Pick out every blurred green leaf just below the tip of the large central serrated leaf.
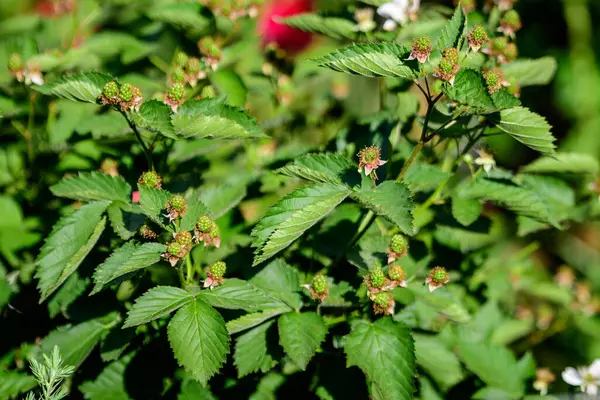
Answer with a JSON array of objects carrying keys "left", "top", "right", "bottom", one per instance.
[{"left": 250, "top": 259, "right": 302, "bottom": 310}]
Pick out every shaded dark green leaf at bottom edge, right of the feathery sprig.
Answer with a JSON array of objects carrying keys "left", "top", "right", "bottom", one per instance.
[{"left": 79, "top": 354, "right": 133, "bottom": 400}]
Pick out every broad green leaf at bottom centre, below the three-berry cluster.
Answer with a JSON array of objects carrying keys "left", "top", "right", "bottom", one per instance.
[{"left": 342, "top": 318, "right": 415, "bottom": 400}]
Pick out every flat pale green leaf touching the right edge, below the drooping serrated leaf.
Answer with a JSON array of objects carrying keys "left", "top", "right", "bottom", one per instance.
[{"left": 523, "top": 153, "right": 600, "bottom": 175}]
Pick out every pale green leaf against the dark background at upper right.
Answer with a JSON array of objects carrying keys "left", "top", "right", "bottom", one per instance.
[{"left": 501, "top": 56, "right": 557, "bottom": 87}]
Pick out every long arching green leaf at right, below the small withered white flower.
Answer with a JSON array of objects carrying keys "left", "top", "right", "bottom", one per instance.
[{"left": 460, "top": 178, "right": 555, "bottom": 224}]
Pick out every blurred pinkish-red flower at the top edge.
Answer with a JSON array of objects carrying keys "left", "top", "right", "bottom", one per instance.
[{"left": 258, "top": 0, "right": 313, "bottom": 53}]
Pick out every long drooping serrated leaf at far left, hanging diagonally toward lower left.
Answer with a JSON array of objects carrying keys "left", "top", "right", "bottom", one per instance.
[{"left": 36, "top": 201, "right": 110, "bottom": 302}]
